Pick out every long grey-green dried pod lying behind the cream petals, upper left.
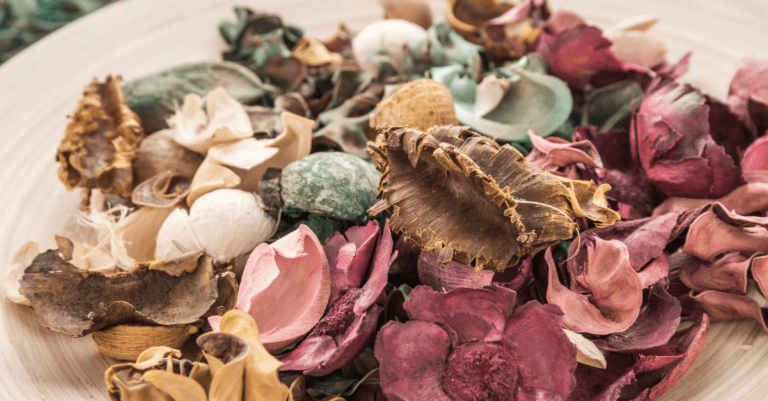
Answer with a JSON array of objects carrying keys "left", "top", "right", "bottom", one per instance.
[{"left": 123, "top": 61, "right": 275, "bottom": 133}]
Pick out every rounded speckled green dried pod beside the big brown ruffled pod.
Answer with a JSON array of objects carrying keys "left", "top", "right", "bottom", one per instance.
[{"left": 280, "top": 152, "right": 380, "bottom": 219}]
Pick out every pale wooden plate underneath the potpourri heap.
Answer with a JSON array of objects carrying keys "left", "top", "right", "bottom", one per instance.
[{"left": 0, "top": 0, "right": 768, "bottom": 401}]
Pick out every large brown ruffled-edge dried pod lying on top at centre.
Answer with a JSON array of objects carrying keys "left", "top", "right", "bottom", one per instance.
[{"left": 368, "top": 126, "right": 609, "bottom": 271}]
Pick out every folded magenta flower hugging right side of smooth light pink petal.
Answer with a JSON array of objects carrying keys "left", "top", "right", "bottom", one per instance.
[{"left": 279, "top": 220, "right": 397, "bottom": 376}]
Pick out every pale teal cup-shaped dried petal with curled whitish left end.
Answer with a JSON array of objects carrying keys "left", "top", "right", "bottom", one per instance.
[{"left": 432, "top": 54, "right": 573, "bottom": 142}]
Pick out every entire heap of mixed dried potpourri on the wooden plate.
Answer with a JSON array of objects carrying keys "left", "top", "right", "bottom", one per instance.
[{"left": 3, "top": 0, "right": 768, "bottom": 401}]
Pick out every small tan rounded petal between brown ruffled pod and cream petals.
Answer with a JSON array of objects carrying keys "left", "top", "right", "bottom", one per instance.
[{"left": 133, "top": 133, "right": 203, "bottom": 185}]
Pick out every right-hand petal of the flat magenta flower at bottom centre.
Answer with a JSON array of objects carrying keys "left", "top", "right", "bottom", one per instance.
[{"left": 503, "top": 301, "right": 576, "bottom": 400}]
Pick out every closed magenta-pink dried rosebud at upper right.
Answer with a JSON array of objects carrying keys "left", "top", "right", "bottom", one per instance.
[{"left": 630, "top": 79, "right": 742, "bottom": 198}]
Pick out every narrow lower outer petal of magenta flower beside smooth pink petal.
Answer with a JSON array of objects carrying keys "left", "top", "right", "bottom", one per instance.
[{"left": 304, "top": 305, "right": 384, "bottom": 376}]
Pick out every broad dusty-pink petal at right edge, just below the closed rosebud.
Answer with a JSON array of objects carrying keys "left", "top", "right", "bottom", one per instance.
[{"left": 683, "top": 208, "right": 768, "bottom": 261}]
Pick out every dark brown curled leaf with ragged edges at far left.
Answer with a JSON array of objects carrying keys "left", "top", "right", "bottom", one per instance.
[{"left": 20, "top": 250, "right": 218, "bottom": 337}]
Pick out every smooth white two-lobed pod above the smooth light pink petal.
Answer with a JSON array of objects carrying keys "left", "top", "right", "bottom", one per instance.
[{"left": 153, "top": 189, "right": 277, "bottom": 264}]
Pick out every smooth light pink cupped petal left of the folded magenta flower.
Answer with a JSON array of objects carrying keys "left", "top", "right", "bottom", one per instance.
[{"left": 209, "top": 224, "right": 331, "bottom": 353}]
